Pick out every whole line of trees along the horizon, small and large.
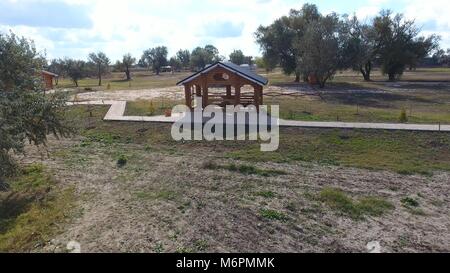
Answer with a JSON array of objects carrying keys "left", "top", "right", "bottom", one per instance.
[{"left": 43, "top": 4, "right": 450, "bottom": 87}]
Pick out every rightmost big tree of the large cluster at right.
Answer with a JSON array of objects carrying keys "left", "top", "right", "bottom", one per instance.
[{"left": 373, "top": 11, "right": 438, "bottom": 81}]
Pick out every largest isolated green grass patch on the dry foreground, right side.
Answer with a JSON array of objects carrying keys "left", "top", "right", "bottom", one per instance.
[{"left": 318, "top": 188, "right": 394, "bottom": 219}]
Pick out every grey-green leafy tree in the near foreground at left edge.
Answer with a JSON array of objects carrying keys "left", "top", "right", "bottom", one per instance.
[{"left": 0, "top": 33, "right": 72, "bottom": 183}]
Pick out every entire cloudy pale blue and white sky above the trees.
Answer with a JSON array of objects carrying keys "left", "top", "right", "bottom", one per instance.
[{"left": 0, "top": 0, "right": 450, "bottom": 60}]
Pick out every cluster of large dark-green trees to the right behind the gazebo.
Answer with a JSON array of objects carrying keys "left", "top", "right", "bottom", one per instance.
[{"left": 255, "top": 4, "right": 443, "bottom": 87}]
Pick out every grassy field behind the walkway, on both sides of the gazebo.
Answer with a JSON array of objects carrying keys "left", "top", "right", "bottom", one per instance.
[{"left": 103, "top": 68, "right": 450, "bottom": 124}]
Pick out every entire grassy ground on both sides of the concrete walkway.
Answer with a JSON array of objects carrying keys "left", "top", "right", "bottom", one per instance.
[{"left": 0, "top": 66, "right": 450, "bottom": 253}]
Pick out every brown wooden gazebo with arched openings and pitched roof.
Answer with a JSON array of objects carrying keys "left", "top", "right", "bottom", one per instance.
[{"left": 177, "top": 62, "right": 268, "bottom": 109}]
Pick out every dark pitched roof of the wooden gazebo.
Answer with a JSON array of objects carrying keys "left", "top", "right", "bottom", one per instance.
[{"left": 177, "top": 62, "right": 269, "bottom": 85}]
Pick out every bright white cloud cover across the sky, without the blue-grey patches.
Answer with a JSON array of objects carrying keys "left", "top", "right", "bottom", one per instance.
[{"left": 0, "top": 0, "right": 450, "bottom": 60}]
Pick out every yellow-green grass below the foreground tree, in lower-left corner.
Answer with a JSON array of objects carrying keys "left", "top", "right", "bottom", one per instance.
[{"left": 0, "top": 165, "right": 74, "bottom": 252}]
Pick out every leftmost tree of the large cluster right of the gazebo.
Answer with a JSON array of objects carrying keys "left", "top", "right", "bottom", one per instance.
[{"left": 255, "top": 4, "right": 321, "bottom": 82}]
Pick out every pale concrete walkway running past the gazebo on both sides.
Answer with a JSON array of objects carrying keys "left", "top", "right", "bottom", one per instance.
[{"left": 67, "top": 101, "right": 450, "bottom": 132}]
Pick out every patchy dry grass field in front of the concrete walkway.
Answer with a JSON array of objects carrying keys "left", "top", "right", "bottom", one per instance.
[{"left": 20, "top": 103, "right": 442, "bottom": 253}]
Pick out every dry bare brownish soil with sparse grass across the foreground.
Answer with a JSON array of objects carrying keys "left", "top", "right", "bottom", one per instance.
[{"left": 21, "top": 138, "right": 450, "bottom": 252}]
